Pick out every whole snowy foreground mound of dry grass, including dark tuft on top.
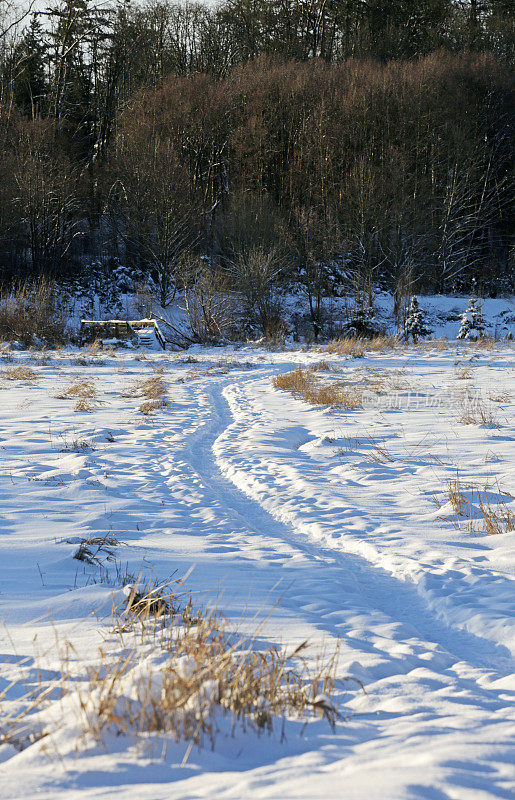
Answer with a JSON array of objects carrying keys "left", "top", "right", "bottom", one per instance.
[{"left": 0, "top": 582, "right": 361, "bottom": 763}]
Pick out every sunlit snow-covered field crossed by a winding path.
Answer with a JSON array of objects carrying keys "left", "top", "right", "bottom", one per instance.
[{"left": 0, "top": 343, "right": 515, "bottom": 800}]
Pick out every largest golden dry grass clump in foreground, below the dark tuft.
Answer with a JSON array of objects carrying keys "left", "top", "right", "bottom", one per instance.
[{"left": 82, "top": 606, "right": 339, "bottom": 760}]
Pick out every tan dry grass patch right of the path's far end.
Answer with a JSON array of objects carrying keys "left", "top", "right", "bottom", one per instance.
[{"left": 273, "top": 367, "right": 363, "bottom": 411}]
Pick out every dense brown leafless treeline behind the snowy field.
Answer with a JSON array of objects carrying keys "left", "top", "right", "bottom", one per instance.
[{"left": 0, "top": 0, "right": 513, "bottom": 306}]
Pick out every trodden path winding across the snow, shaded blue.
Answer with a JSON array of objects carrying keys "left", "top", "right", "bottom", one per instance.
[{"left": 177, "top": 379, "right": 513, "bottom": 675}]
